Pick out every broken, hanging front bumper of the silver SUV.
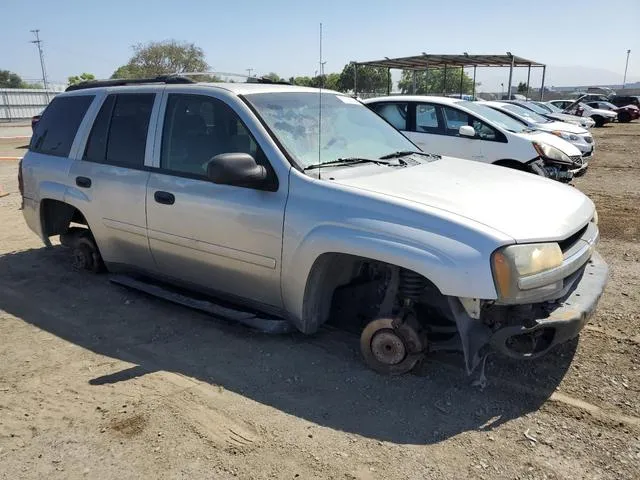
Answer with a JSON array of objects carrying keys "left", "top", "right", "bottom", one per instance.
[{"left": 489, "top": 252, "right": 609, "bottom": 359}]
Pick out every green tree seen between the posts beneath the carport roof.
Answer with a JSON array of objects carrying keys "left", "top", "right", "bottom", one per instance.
[{"left": 398, "top": 67, "right": 473, "bottom": 94}]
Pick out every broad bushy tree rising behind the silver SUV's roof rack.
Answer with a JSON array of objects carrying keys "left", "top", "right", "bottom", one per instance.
[{"left": 111, "top": 40, "right": 209, "bottom": 80}]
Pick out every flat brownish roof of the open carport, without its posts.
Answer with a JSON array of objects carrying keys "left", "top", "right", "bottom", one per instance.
[{"left": 356, "top": 53, "right": 545, "bottom": 70}]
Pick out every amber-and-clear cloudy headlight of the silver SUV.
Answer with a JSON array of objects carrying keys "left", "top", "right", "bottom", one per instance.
[{"left": 491, "top": 243, "right": 564, "bottom": 301}]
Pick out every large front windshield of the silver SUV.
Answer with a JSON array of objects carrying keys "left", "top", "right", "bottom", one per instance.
[{"left": 246, "top": 92, "right": 418, "bottom": 168}]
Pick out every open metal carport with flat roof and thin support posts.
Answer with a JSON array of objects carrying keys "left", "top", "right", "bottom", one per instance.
[{"left": 353, "top": 52, "right": 547, "bottom": 98}]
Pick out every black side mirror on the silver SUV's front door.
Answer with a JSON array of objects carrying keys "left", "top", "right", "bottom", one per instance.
[{"left": 207, "top": 153, "right": 267, "bottom": 187}]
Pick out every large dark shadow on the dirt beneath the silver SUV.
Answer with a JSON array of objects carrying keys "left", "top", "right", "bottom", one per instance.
[{"left": 0, "top": 247, "right": 576, "bottom": 444}]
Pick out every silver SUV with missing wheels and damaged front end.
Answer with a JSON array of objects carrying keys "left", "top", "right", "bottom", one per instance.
[{"left": 20, "top": 76, "right": 607, "bottom": 374}]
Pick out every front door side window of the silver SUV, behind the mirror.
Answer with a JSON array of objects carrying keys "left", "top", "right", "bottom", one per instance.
[{"left": 160, "top": 94, "right": 266, "bottom": 176}]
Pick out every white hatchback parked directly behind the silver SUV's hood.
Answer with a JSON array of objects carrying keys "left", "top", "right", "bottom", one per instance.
[{"left": 364, "top": 95, "right": 583, "bottom": 182}]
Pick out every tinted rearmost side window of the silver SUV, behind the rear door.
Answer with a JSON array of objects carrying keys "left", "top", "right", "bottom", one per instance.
[{"left": 29, "top": 95, "right": 94, "bottom": 157}]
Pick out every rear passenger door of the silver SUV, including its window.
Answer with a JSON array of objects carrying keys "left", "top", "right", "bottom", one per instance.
[{"left": 68, "top": 89, "right": 159, "bottom": 271}]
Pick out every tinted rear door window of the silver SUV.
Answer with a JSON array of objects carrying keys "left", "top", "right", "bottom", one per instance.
[{"left": 84, "top": 93, "right": 155, "bottom": 168}]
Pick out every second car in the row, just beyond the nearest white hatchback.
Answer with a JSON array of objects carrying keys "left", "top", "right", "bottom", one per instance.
[{"left": 484, "top": 101, "right": 595, "bottom": 161}]
